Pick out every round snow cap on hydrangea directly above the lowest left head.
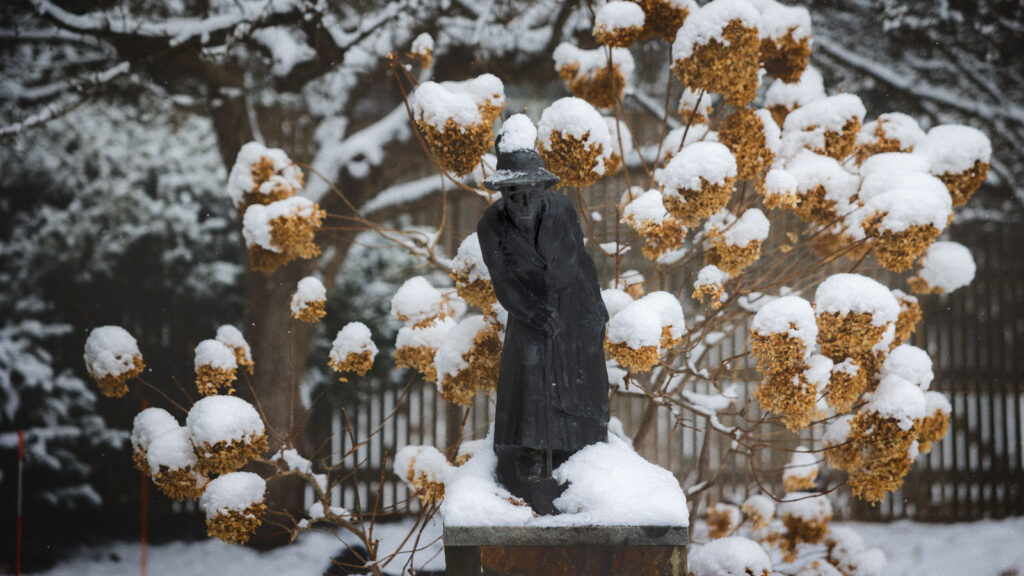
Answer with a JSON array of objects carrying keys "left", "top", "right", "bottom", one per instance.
[{"left": 185, "top": 396, "right": 263, "bottom": 446}]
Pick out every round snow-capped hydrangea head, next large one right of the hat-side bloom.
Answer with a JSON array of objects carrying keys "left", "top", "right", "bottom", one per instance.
[{"left": 654, "top": 141, "right": 737, "bottom": 225}]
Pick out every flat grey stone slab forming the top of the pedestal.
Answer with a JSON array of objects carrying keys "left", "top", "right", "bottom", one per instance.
[{"left": 443, "top": 526, "right": 689, "bottom": 546}]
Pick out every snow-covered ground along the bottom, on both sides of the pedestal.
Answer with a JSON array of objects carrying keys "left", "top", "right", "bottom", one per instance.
[{"left": 25, "top": 518, "right": 1024, "bottom": 576}]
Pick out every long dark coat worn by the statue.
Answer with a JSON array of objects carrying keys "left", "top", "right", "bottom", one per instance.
[{"left": 477, "top": 192, "right": 608, "bottom": 452}]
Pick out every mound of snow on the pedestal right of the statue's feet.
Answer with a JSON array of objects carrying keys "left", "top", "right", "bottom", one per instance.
[{"left": 553, "top": 435, "right": 689, "bottom": 526}]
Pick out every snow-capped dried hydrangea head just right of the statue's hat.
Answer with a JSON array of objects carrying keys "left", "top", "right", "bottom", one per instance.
[{"left": 537, "top": 97, "right": 614, "bottom": 188}]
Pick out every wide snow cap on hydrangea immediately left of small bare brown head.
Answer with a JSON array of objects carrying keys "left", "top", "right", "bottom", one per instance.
[{"left": 814, "top": 274, "right": 899, "bottom": 326}]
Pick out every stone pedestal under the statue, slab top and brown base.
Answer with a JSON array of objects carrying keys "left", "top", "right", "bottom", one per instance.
[{"left": 444, "top": 526, "right": 688, "bottom": 576}]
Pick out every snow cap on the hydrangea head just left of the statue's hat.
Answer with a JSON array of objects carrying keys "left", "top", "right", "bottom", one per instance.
[{"left": 412, "top": 74, "right": 505, "bottom": 130}]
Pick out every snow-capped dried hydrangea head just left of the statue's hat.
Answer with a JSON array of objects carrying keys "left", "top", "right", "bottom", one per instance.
[{"left": 412, "top": 74, "right": 505, "bottom": 176}]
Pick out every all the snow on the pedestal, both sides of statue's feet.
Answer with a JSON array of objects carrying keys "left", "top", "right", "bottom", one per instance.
[{"left": 440, "top": 434, "right": 689, "bottom": 527}]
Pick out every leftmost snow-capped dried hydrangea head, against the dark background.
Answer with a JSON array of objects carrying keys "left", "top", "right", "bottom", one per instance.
[{"left": 84, "top": 326, "right": 145, "bottom": 398}]
